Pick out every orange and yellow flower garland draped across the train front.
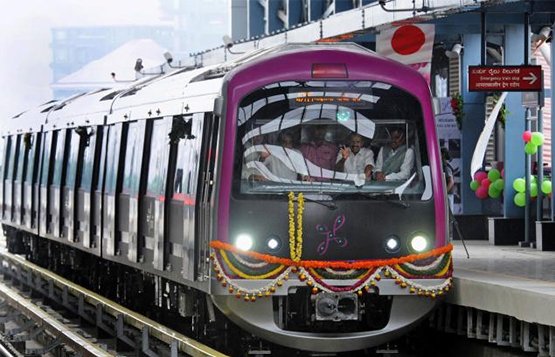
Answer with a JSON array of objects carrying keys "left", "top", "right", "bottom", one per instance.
[{"left": 210, "top": 192, "right": 453, "bottom": 301}]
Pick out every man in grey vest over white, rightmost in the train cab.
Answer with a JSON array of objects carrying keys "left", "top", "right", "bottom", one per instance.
[{"left": 374, "top": 127, "right": 414, "bottom": 181}]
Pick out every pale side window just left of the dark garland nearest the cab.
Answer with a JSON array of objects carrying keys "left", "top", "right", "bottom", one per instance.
[{"left": 146, "top": 117, "right": 173, "bottom": 196}]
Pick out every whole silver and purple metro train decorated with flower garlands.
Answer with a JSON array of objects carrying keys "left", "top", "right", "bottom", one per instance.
[{"left": 0, "top": 43, "right": 453, "bottom": 353}]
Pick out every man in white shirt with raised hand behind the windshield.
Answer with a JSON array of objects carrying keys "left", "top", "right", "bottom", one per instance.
[{"left": 335, "top": 133, "right": 376, "bottom": 179}]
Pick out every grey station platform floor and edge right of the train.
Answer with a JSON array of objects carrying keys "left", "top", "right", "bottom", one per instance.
[{"left": 446, "top": 237, "right": 555, "bottom": 327}]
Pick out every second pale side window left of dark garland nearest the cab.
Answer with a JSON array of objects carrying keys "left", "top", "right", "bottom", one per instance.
[{"left": 122, "top": 121, "right": 145, "bottom": 195}]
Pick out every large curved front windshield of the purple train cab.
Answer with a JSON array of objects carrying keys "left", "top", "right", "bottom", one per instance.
[{"left": 234, "top": 81, "right": 431, "bottom": 199}]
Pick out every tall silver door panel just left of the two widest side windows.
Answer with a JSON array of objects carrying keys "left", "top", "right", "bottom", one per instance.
[{"left": 101, "top": 123, "right": 125, "bottom": 257}]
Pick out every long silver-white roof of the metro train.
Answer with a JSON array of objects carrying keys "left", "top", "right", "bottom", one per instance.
[{"left": 4, "top": 43, "right": 396, "bottom": 135}]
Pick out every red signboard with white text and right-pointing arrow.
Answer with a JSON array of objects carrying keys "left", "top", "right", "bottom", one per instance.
[{"left": 468, "top": 65, "right": 543, "bottom": 92}]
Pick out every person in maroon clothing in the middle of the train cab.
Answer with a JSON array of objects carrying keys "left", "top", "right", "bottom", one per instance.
[{"left": 301, "top": 125, "right": 337, "bottom": 170}]
